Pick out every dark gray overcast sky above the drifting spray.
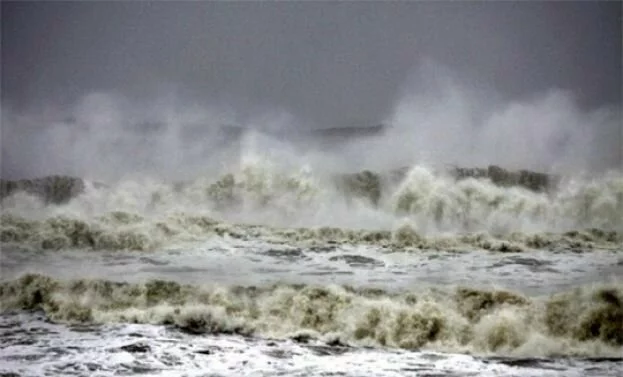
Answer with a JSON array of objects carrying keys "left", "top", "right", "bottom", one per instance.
[{"left": 2, "top": 1, "right": 622, "bottom": 126}]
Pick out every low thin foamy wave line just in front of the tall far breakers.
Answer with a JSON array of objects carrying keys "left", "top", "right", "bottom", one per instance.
[{"left": 0, "top": 212, "right": 623, "bottom": 252}]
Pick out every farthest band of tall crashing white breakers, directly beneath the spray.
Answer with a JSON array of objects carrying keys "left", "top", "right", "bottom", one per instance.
[{"left": 0, "top": 161, "right": 623, "bottom": 251}]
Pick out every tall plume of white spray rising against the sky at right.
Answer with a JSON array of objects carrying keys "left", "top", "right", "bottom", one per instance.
[{"left": 388, "top": 62, "right": 621, "bottom": 174}]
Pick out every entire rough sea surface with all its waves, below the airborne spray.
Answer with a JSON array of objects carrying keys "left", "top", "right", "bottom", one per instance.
[{"left": 0, "top": 160, "right": 623, "bottom": 377}]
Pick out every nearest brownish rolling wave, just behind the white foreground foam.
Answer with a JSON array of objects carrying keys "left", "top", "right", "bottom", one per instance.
[{"left": 0, "top": 274, "right": 623, "bottom": 357}]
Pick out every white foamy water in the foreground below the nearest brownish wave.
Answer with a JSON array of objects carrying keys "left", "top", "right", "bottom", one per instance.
[{"left": 0, "top": 314, "right": 623, "bottom": 377}]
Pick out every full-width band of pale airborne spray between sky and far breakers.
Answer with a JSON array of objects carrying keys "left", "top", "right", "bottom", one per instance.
[{"left": 2, "top": 61, "right": 622, "bottom": 181}]
